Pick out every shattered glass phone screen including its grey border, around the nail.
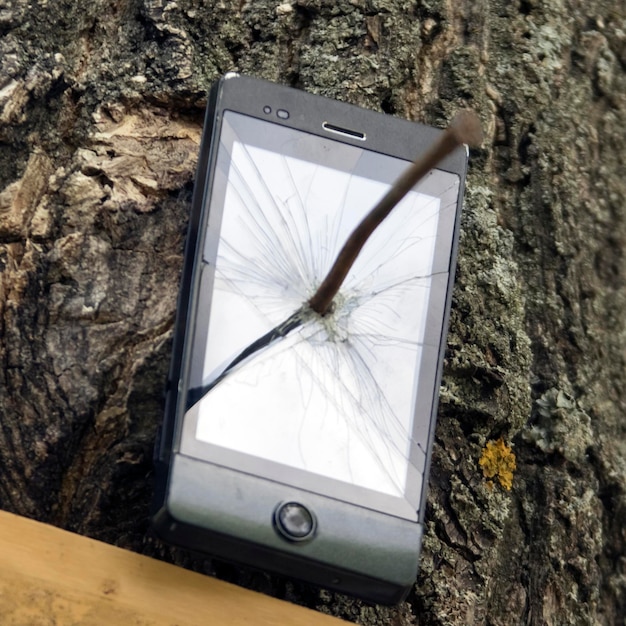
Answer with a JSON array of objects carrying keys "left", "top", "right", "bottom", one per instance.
[{"left": 181, "top": 112, "right": 459, "bottom": 519}]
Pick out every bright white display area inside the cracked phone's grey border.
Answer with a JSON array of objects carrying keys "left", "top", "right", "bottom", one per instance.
[{"left": 189, "top": 136, "right": 444, "bottom": 496}]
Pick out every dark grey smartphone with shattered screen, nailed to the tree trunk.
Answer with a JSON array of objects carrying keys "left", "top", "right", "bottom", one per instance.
[{"left": 153, "top": 73, "right": 467, "bottom": 604}]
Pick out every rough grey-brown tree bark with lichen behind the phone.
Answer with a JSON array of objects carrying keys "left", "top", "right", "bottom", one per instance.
[{"left": 0, "top": 0, "right": 626, "bottom": 626}]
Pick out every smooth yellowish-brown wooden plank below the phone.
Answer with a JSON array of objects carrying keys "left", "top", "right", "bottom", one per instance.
[{"left": 0, "top": 511, "right": 346, "bottom": 626}]
